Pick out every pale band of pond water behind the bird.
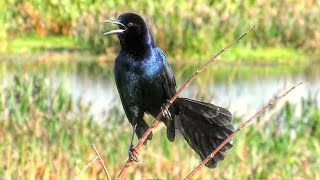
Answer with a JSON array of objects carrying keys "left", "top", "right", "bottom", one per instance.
[{"left": 0, "top": 59, "right": 320, "bottom": 119}]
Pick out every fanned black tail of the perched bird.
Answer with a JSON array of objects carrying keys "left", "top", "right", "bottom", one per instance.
[{"left": 174, "top": 98, "right": 234, "bottom": 168}]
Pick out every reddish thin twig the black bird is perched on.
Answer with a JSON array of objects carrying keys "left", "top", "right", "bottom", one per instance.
[{"left": 117, "top": 26, "right": 255, "bottom": 179}]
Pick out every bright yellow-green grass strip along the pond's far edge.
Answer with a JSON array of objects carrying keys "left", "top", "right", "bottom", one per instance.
[{"left": 0, "top": 35, "right": 310, "bottom": 65}]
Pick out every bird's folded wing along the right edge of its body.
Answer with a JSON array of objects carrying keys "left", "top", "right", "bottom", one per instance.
[{"left": 157, "top": 48, "right": 176, "bottom": 99}]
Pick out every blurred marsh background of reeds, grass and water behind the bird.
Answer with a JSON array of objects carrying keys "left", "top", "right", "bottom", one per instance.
[{"left": 0, "top": 0, "right": 320, "bottom": 179}]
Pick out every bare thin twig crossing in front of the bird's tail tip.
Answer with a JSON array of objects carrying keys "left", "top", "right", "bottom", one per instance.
[{"left": 185, "top": 82, "right": 302, "bottom": 180}]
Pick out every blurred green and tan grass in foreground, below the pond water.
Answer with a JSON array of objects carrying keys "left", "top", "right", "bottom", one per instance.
[{"left": 0, "top": 75, "right": 320, "bottom": 179}]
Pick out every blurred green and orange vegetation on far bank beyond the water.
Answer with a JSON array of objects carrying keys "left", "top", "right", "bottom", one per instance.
[{"left": 0, "top": 0, "right": 320, "bottom": 60}]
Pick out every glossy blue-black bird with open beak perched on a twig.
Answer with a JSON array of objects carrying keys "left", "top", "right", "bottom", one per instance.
[{"left": 104, "top": 13, "right": 234, "bottom": 168}]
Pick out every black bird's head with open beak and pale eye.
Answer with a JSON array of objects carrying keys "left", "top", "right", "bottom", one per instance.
[{"left": 103, "top": 13, "right": 154, "bottom": 49}]
